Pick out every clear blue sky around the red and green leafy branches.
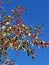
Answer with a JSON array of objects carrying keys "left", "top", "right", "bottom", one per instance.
[{"left": 2, "top": 0, "right": 49, "bottom": 65}]
